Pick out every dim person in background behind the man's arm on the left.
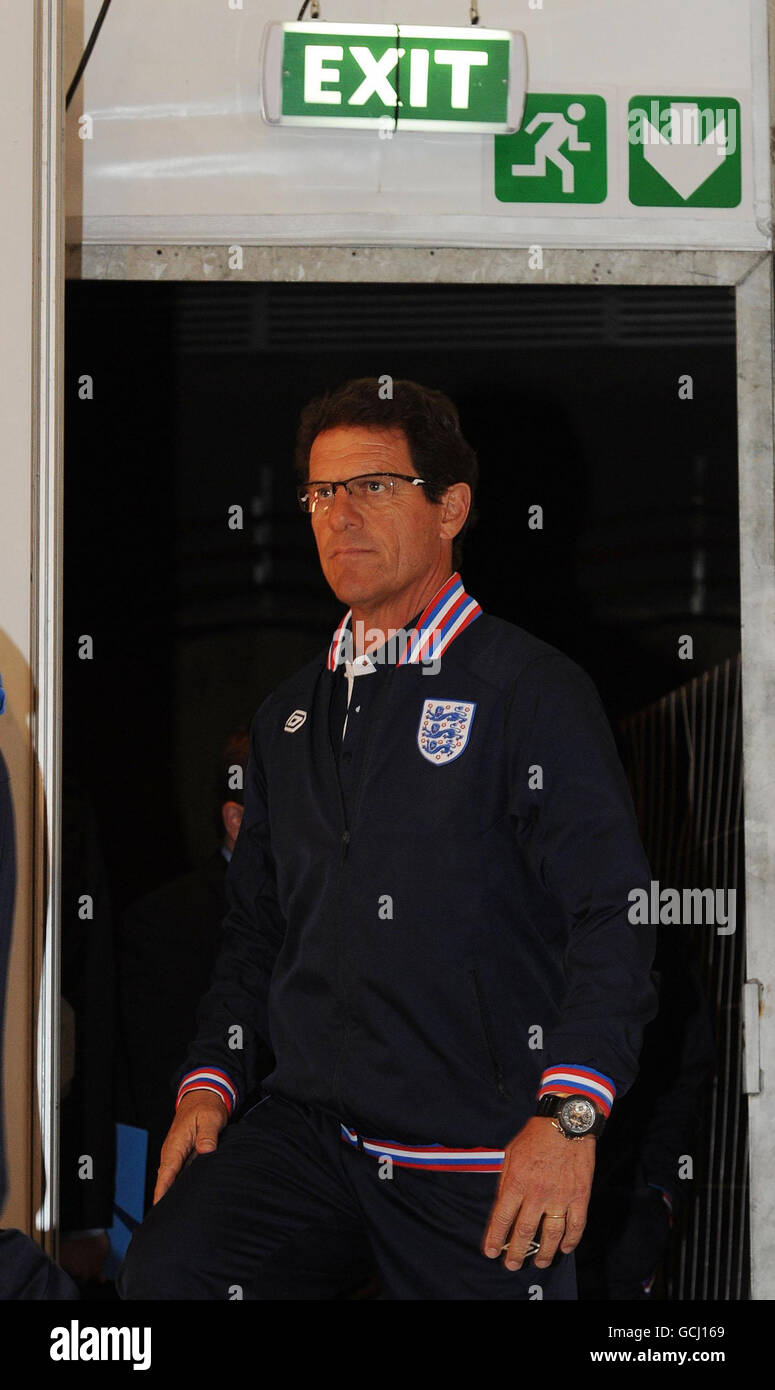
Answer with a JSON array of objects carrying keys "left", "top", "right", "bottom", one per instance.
[{"left": 119, "top": 727, "right": 272, "bottom": 1208}]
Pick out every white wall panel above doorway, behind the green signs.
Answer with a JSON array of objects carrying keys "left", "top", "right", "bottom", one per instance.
[{"left": 67, "top": 0, "right": 769, "bottom": 249}]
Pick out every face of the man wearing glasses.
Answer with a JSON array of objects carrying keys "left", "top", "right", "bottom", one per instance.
[{"left": 310, "top": 425, "right": 449, "bottom": 607}]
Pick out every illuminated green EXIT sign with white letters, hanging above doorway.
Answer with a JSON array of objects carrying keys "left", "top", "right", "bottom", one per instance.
[{"left": 261, "top": 21, "right": 526, "bottom": 135}]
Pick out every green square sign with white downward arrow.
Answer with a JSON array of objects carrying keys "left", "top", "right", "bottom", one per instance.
[{"left": 628, "top": 96, "right": 740, "bottom": 207}]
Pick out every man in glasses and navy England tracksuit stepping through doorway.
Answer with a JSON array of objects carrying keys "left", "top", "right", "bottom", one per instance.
[{"left": 119, "top": 379, "right": 656, "bottom": 1300}]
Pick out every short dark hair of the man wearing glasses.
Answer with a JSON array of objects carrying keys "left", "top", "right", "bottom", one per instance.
[{"left": 293, "top": 377, "right": 479, "bottom": 570}]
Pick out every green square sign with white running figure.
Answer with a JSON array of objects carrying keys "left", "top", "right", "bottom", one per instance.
[{"left": 494, "top": 92, "right": 607, "bottom": 203}]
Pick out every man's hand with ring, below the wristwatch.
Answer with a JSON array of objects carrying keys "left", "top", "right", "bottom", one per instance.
[{"left": 482, "top": 1115, "right": 597, "bottom": 1269}]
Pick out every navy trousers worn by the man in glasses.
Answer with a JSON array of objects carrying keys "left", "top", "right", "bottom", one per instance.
[{"left": 117, "top": 1095, "right": 576, "bottom": 1300}]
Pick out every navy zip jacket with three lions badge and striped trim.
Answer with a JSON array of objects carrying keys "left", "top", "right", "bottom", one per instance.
[{"left": 174, "top": 573, "right": 656, "bottom": 1148}]
